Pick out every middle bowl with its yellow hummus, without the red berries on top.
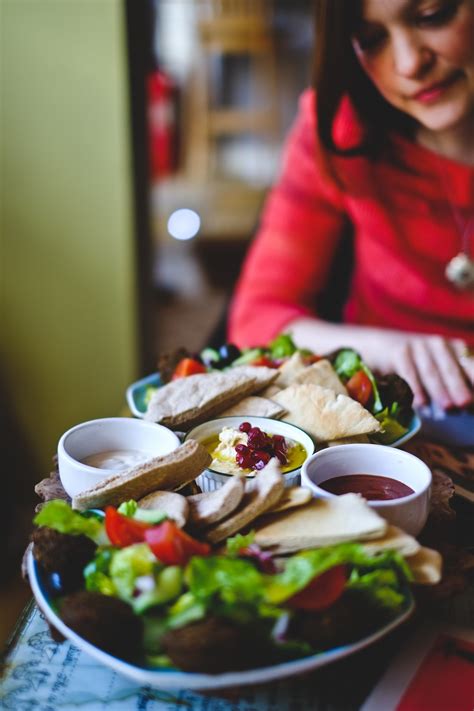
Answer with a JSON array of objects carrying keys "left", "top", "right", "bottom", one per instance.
[{"left": 185, "top": 415, "right": 314, "bottom": 491}]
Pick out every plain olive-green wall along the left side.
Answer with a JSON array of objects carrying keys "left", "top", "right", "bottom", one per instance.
[{"left": 0, "top": 0, "right": 139, "bottom": 471}]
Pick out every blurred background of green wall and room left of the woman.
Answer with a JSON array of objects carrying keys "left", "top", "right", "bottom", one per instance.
[{"left": 0, "top": 0, "right": 312, "bottom": 641}]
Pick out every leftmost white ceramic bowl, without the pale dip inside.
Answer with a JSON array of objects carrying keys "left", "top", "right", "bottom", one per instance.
[{"left": 58, "top": 417, "right": 180, "bottom": 498}]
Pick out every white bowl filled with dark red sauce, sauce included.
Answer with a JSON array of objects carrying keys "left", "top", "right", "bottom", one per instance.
[{"left": 301, "top": 444, "right": 432, "bottom": 536}]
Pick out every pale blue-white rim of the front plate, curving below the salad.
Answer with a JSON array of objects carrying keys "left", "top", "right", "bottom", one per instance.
[{"left": 27, "top": 551, "right": 414, "bottom": 689}]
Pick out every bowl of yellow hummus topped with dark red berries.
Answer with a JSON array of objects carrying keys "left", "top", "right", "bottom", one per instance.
[{"left": 185, "top": 416, "right": 314, "bottom": 491}]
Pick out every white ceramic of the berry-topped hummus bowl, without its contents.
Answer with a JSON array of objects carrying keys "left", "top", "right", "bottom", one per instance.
[{"left": 185, "top": 415, "right": 314, "bottom": 491}]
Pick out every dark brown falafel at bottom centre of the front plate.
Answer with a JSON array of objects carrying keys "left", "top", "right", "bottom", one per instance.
[{"left": 163, "top": 617, "right": 274, "bottom": 674}]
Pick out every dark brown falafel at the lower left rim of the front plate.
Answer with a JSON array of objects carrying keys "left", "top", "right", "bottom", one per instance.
[{"left": 59, "top": 590, "right": 143, "bottom": 661}]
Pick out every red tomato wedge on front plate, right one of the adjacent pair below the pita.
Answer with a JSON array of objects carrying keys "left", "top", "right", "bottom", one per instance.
[{"left": 145, "top": 521, "right": 211, "bottom": 565}]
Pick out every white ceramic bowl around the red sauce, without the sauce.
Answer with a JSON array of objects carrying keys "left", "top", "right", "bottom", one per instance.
[{"left": 301, "top": 444, "right": 431, "bottom": 536}]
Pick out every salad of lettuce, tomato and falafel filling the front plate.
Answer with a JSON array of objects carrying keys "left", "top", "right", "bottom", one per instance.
[{"left": 32, "top": 500, "right": 412, "bottom": 673}]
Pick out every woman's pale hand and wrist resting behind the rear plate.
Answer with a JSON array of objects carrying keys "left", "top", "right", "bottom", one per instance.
[{"left": 287, "top": 318, "right": 474, "bottom": 410}]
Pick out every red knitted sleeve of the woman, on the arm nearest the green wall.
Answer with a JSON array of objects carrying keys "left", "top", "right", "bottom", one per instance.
[{"left": 228, "top": 90, "right": 347, "bottom": 347}]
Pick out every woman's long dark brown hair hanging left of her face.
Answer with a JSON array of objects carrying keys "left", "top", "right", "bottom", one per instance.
[{"left": 313, "top": 0, "right": 413, "bottom": 157}]
